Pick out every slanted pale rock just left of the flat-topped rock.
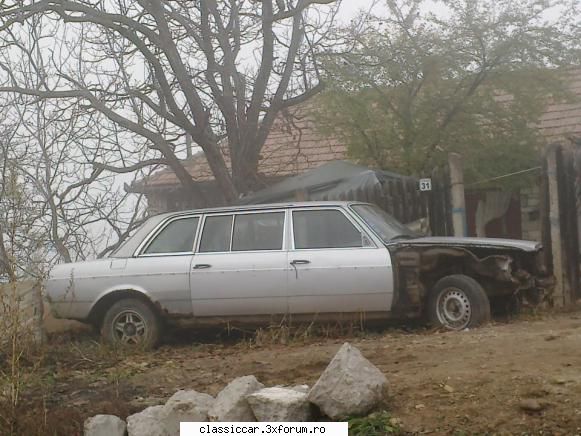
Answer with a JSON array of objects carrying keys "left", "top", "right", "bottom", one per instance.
[{"left": 208, "top": 375, "right": 264, "bottom": 422}]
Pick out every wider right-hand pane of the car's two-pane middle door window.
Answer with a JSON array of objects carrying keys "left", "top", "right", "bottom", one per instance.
[{"left": 232, "top": 212, "right": 284, "bottom": 251}]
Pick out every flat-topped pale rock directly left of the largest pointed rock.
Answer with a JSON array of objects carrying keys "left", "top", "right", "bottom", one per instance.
[{"left": 246, "top": 387, "right": 311, "bottom": 422}]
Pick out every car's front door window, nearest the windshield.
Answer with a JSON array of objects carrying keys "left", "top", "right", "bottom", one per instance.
[{"left": 293, "top": 209, "right": 370, "bottom": 249}]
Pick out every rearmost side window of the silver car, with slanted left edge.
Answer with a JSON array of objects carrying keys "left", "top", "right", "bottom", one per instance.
[{"left": 143, "top": 217, "right": 199, "bottom": 254}]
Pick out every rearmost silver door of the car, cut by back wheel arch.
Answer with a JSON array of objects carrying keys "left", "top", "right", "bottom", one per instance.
[{"left": 119, "top": 216, "right": 200, "bottom": 315}]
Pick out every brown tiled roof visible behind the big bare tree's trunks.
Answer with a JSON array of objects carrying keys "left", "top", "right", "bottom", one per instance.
[{"left": 132, "top": 107, "right": 347, "bottom": 190}]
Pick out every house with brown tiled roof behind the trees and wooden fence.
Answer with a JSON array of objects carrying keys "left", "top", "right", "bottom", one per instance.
[{"left": 130, "top": 70, "right": 581, "bottom": 240}]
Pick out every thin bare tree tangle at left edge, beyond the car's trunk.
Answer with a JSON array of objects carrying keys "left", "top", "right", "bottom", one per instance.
[{"left": 0, "top": 94, "right": 144, "bottom": 281}]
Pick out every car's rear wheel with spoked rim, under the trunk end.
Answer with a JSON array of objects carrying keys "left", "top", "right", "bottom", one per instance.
[{"left": 101, "top": 298, "right": 161, "bottom": 349}]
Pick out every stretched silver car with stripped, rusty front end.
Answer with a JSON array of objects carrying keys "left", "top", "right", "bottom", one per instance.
[{"left": 46, "top": 202, "right": 552, "bottom": 347}]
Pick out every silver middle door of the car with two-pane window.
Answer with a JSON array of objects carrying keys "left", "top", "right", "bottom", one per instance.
[{"left": 190, "top": 210, "right": 288, "bottom": 317}]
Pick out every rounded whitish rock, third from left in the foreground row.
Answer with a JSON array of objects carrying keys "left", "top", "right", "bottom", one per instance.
[{"left": 162, "top": 391, "right": 214, "bottom": 435}]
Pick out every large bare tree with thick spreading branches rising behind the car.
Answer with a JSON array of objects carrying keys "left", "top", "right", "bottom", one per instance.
[{"left": 0, "top": 0, "right": 337, "bottom": 200}]
